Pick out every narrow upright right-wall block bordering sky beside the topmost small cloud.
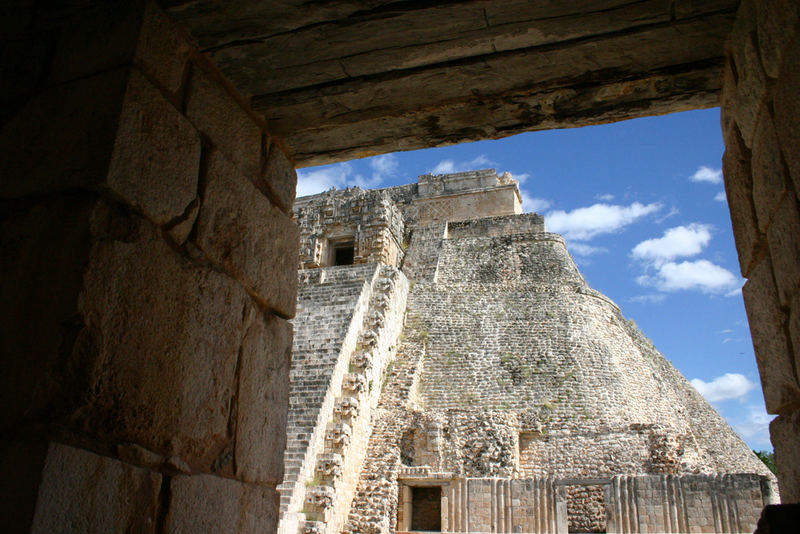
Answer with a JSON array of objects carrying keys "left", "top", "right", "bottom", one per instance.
[{"left": 722, "top": 125, "right": 759, "bottom": 277}]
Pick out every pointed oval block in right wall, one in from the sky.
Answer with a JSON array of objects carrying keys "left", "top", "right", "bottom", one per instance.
[{"left": 752, "top": 109, "right": 789, "bottom": 232}]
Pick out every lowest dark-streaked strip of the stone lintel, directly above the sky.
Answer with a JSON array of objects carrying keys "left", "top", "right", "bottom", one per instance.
[{"left": 276, "top": 59, "right": 722, "bottom": 167}]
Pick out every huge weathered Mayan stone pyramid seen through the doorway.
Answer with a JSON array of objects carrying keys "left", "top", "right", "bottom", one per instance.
[{"left": 279, "top": 170, "right": 778, "bottom": 534}]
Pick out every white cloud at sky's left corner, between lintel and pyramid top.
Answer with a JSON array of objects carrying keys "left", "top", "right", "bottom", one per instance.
[{"left": 297, "top": 154, "right": 400, "bottom": 197}]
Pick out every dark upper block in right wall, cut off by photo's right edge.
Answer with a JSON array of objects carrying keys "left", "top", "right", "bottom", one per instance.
[{"left": 773, "top": 32, "right": 800, "bottom": 196}]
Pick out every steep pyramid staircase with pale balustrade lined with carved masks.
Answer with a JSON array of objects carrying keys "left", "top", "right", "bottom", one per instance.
[{"left": 279, "top": 264, "right": 408, "bottom": 534}]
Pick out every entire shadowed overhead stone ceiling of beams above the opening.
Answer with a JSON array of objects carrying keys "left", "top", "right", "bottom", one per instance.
[{"left": 170, "top": 0, "right": 738, "bottom": 166}]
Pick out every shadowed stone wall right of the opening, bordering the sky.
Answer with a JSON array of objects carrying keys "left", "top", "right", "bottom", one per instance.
[{"left": 722, "top": 0, "right": 800, "bottom": 503}]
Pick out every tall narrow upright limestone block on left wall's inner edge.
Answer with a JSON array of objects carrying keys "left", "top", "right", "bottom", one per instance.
[{"left": 236, "top": 313, "right": 292, "bottom": 485}]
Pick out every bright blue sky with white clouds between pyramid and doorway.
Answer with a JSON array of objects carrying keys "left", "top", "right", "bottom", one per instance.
[{"left": 298, "top": 109, "right": 772, "bottom": 450}]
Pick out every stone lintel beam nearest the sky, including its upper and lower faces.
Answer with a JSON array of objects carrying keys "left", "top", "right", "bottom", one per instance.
[{"left": 251, "top": 13, "right": 732, "bottom": 166}]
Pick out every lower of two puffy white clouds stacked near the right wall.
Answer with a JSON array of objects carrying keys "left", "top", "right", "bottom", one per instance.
[{"left": 636, "top": 260, "right": 739, "bottom": 293}]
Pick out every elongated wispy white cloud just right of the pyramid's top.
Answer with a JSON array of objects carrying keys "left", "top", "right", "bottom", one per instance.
[{"left": 545, "top": 202, "right": 661, "bottom": 241}]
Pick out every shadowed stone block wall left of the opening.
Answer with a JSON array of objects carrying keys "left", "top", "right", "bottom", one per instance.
[{"left": 0, "top": 2, "right": 298, "bottom": 532}]
